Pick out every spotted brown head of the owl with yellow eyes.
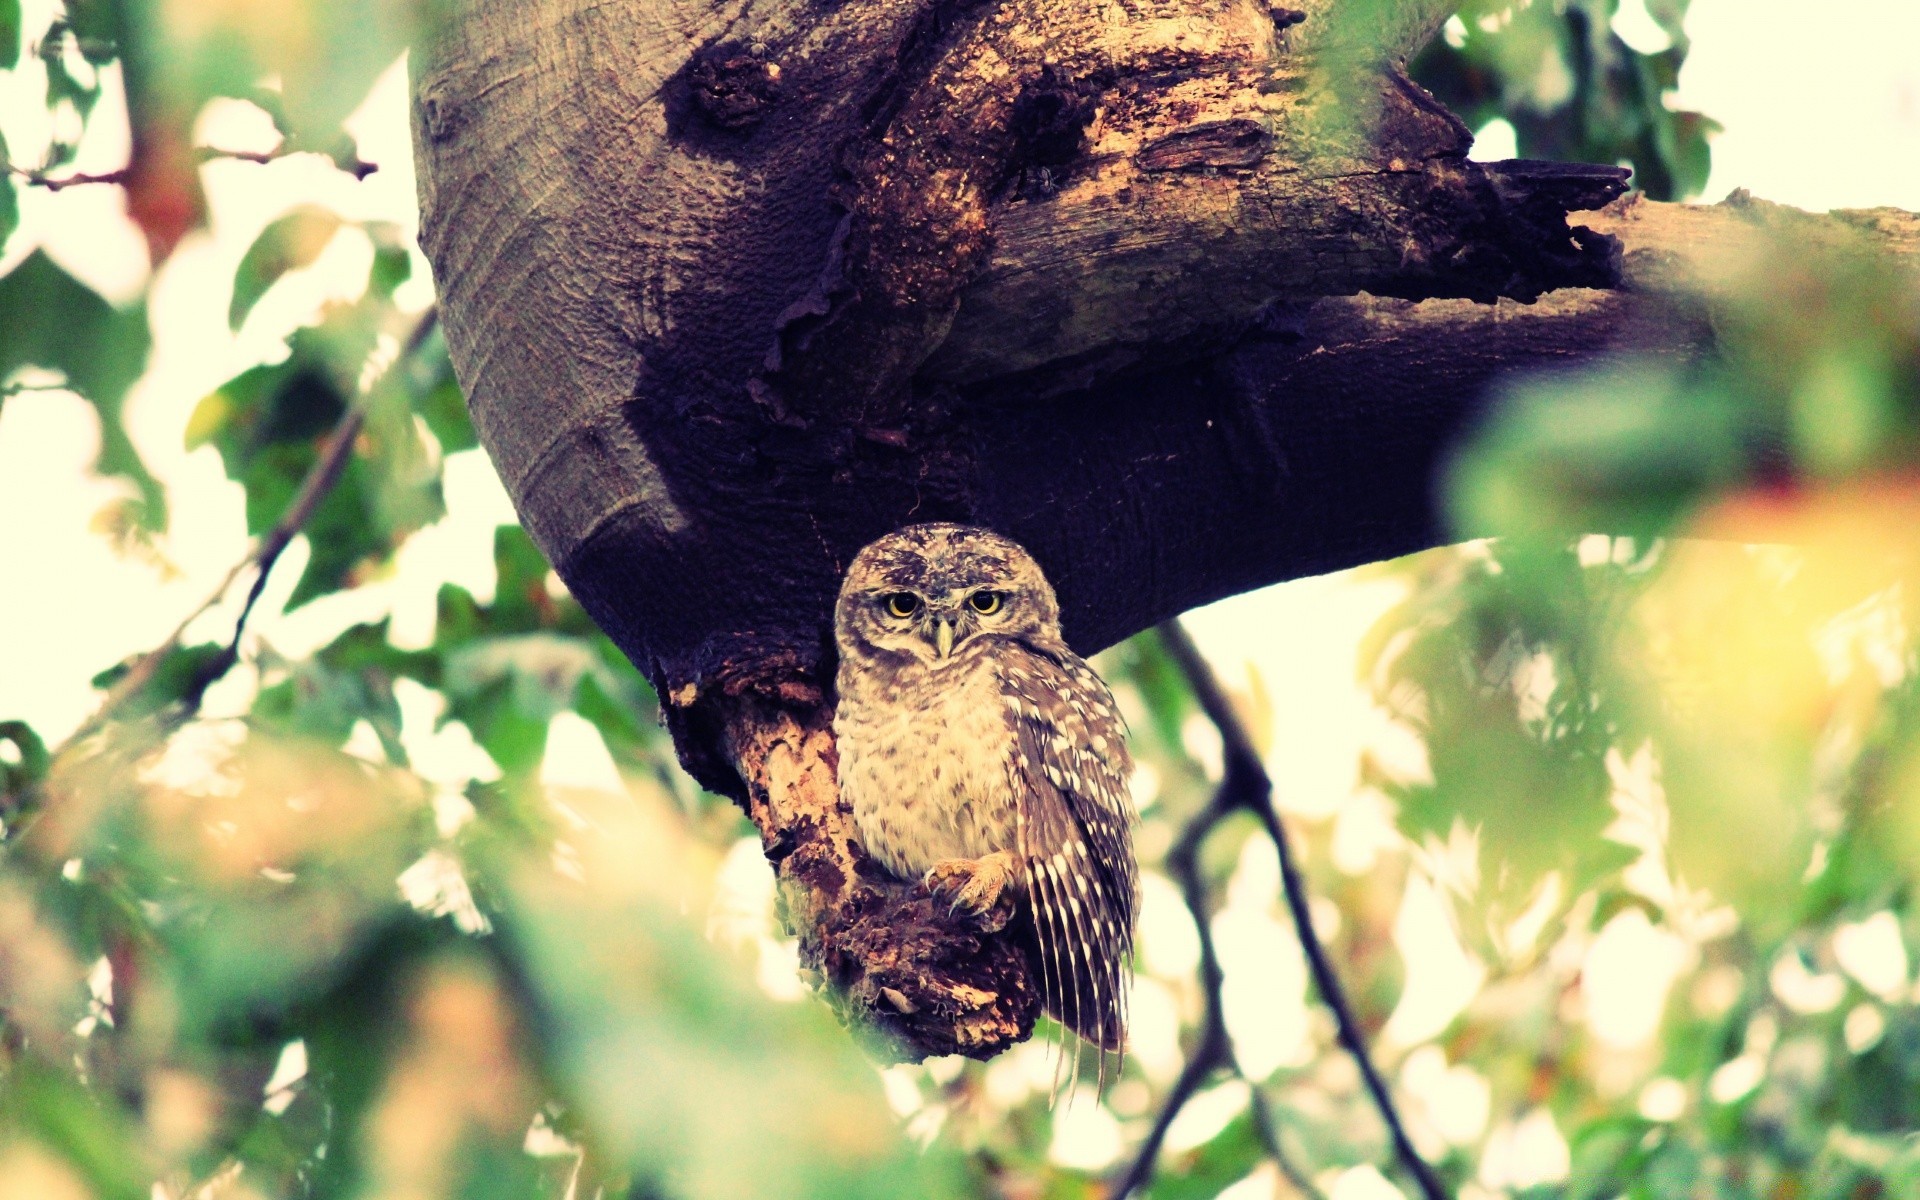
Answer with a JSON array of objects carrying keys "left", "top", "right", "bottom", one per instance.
[{"left": 833, "top": 524, "right": 1060, "bottom": 662}]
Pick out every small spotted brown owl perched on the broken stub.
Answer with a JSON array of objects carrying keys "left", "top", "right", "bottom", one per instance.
[{"left": 833, "top": 524, "right": 1139, "bottom": 1073}]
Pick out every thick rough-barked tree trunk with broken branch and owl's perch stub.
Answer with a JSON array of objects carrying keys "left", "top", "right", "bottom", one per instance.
[{"left": 413, "top": 0, "right": 1920, "bottom": 1056}]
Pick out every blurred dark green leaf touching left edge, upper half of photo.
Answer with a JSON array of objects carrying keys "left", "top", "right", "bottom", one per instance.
[{"left": 0, "top": 250, "right": 167, "bottom": 530}]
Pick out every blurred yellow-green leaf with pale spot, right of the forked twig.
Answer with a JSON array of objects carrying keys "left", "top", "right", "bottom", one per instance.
[{"left": 1363, "top": 540, "right": 1645, "bottom": 937}]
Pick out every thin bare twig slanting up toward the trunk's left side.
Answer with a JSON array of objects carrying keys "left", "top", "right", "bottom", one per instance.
[{"left": 60, "top": 309, "right": 440, "bottom": 753}]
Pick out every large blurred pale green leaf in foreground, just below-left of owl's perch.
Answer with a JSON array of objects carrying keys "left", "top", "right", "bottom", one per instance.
[{"left": 497, "top": 793, "right": 960, "bottom": 1200}]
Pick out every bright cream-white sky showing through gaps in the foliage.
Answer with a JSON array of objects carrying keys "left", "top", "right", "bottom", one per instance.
[{"left": 0, "top": 0, "right": 1920, "bottom": 1196}]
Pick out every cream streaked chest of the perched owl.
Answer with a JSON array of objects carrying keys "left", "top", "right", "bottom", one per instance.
[{"left": 833, "top": 662, "right": 1014, "bottom": 877}]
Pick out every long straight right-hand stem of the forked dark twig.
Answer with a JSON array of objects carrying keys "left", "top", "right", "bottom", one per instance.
[{"left": 1160, "top": 620, "right": 1448, "bottom": 1200}]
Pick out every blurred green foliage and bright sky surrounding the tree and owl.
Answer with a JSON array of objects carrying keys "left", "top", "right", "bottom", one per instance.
[{"left": 0, "top": 0, "right": 1920, "bottom": 1200}]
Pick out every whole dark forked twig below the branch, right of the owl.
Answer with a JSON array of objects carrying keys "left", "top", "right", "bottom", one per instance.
[{"left": 1114, "top": 620, "right": 1448, "bottom": 1200}]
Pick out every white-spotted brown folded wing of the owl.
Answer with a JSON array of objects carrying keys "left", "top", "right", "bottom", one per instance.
[{"left": 1000, "top": 647, "right": 1139, "bottom": 1050}]
